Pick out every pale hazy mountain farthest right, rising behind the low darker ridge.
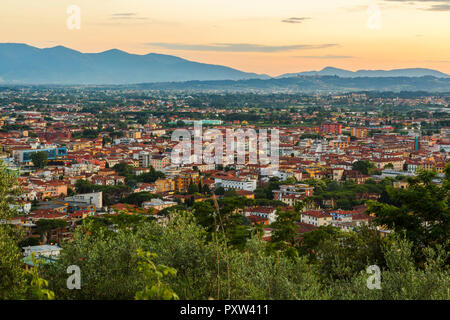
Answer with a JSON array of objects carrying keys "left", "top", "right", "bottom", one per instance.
[{"left": 277, "top": 67, "right": 450, "bottom": 78}]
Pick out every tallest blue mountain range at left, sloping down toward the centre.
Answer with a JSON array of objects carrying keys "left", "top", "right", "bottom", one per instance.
[{"left": 0, "top": 43, "right": 270, "bottom": 84}]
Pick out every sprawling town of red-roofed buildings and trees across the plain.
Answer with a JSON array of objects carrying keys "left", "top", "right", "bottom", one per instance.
[{"left": 0, "top": 87, "right": 450, "bottom": 300}]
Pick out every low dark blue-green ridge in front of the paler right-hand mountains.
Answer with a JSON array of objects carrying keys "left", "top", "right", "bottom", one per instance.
[{"left": 130, "top": 76, "right": 450, "bottom": 93}]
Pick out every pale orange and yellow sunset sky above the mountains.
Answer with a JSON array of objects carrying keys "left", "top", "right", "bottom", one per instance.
[{"left": 0, "top": 0, "right": 450, "bottom": 75}]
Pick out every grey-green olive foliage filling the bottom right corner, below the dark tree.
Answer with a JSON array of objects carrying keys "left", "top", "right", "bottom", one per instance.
[{"left": 329, "top": 234, "right": 450, "bottom": 300}]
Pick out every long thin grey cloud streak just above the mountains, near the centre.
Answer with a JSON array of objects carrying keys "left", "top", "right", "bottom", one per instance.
[{"left": 147, "top": 42, "right": 338, "bottom": 52}]
